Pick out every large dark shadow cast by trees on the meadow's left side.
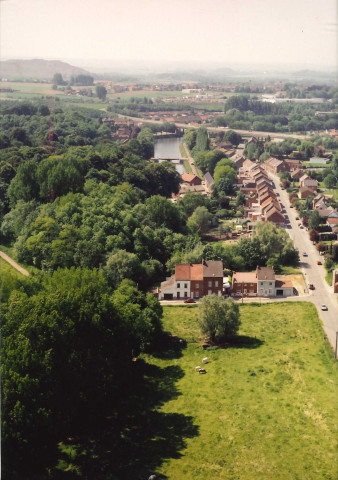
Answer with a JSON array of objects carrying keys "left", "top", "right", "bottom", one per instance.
[{"left": 55, "top": 350, "right": 199, "bottom": 480}]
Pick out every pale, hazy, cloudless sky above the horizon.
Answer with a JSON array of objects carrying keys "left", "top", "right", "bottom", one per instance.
[{"left": 0, "top": 0, "right": 338, "bottom": 69}]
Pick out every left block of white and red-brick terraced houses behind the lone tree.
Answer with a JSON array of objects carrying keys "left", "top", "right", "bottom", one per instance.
[{"left": 160, "top": 260, "right": 223, "bottom": 300}]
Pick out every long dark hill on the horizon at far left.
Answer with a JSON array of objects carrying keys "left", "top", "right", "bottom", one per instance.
[{"left": 0, "top": 59, "right": 89, "bottom": 80}]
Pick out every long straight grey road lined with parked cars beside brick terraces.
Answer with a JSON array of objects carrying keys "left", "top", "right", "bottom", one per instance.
[{"left": 270, "top": 175, "right": 338, "bottom": 348}]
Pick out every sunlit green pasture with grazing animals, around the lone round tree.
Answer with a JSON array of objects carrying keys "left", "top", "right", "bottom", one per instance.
[{"left": 146, "top": 302, "right": 338, "bottom": 480}]
